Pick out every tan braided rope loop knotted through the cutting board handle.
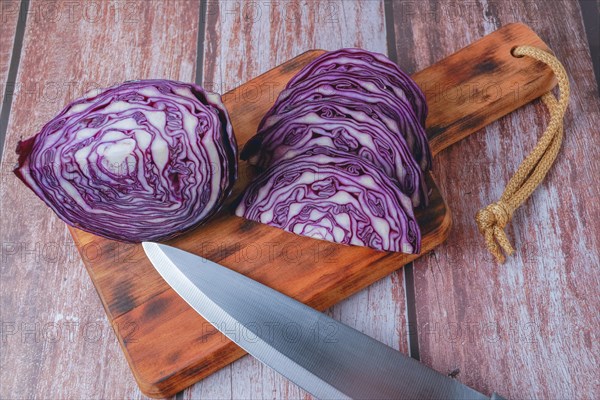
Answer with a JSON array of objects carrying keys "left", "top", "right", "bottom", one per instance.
[{"left": 475, "top": 46, "right": 570, "bottom": 263}]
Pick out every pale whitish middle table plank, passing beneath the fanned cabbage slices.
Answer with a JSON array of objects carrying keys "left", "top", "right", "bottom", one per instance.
[{"left": 192, "top": 1, "right": 407, "bottom": 399}]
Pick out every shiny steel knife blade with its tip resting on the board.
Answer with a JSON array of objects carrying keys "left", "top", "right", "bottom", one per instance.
[{"left": 143, "top": 242, "right": 501, "bottom": 400}]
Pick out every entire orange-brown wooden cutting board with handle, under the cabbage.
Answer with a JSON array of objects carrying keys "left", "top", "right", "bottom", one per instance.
[{"left": 70, "top": 24, "right": 555, "bottom": 397}]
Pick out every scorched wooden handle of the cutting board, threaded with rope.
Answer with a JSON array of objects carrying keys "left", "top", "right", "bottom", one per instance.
[{"left": 412, "top": 23, "right": 556, "bottom": 156}]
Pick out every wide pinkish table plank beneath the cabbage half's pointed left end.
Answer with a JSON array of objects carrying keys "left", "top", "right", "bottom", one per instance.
[{"left": 0, "top": 0, "right": 200, "bottom": 398}]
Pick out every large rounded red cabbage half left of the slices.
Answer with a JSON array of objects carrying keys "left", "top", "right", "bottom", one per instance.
[{"left": 15, "top": 80, "right": 237, "bottom": 242}]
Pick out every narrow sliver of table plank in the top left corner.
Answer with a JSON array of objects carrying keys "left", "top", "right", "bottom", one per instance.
[{"left": 0, "top": 1, "right": 19, "bottom": 110}]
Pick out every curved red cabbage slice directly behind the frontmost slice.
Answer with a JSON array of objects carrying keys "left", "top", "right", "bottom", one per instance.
[{"left": 244, "top": 99, "right": 427, "bottom": 206}]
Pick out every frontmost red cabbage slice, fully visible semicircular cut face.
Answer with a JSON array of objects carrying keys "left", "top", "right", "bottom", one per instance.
[{"left": 236, "top": 149, "right": 421, "bottom": 253}]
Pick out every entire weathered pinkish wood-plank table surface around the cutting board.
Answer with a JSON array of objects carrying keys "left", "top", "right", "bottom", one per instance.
[{"left": 0, "top": 0, "right": 600, "bottom": 399}]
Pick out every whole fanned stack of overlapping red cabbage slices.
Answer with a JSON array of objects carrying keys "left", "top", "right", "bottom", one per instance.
[{"left": 236, "top": 49, "right": 431, "bottom": 253}]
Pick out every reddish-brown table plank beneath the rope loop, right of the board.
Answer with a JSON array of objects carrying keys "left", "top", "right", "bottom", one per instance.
[{"left": 394, "top": 1, "right": 600, "bottom": 398}]
